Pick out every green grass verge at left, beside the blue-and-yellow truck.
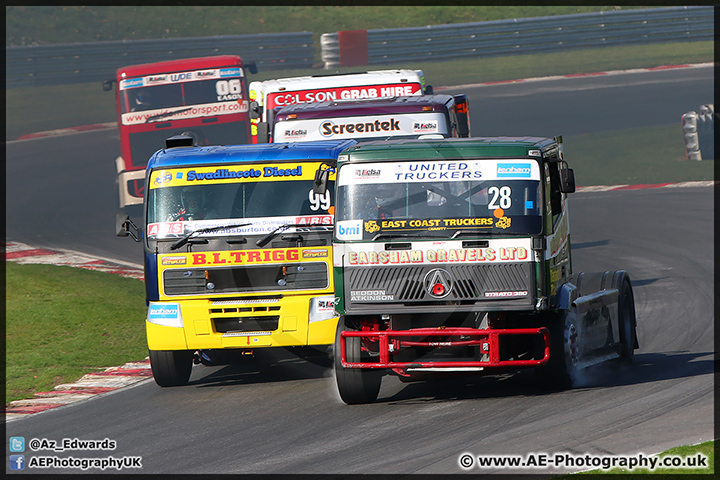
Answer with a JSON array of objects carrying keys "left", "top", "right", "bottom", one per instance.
[{"left": 5, "top": 262, "right": 147, "bottom": 404}]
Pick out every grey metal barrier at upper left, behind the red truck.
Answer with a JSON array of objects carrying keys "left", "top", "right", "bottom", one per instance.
[{"left": 5, "top": 32, "right": 313, "bottom": 88}]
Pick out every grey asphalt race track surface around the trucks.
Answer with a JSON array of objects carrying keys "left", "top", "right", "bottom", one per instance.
[{"left": 6, "top": 65, "right": 714, "bottom": 474}]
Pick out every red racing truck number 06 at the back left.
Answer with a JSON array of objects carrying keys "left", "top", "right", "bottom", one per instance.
[{"left": 103, "top": 55, "right": 257, "bottom": 207}]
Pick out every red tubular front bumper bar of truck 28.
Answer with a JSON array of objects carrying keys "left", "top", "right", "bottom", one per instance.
[{"left": 340, "top": 327, "right": 550, "bottom": 369}]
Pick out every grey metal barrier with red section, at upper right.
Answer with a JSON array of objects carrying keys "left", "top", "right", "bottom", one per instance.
[{"left": 320, "top": 6, "right": 714, "bottom": 68}]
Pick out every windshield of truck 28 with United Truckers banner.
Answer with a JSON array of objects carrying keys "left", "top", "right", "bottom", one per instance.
[{"left": 336, "top": 159, "right": 542, "bottom": 240}]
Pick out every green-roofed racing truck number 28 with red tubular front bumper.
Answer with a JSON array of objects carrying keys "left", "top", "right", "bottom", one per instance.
[{"left": 324, "top": 137, "right": 638, "bottom": 404}]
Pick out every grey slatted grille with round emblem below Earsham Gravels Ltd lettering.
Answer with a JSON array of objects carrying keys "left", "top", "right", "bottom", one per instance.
[{"left": 345, "top": 262, "right": 533, "bottom": 303}]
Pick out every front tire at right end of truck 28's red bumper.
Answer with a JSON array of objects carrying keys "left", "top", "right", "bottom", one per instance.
[{"left": 535, "top": 311, "right": 580, "bottom": 390}]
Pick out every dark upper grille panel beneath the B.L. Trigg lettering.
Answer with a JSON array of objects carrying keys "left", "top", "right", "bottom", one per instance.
[{"left": 163, "top": 262, "right": 330, "bottom": 296}]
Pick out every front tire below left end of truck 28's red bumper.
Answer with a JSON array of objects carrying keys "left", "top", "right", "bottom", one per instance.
[{"left": 333, "top": 317, "right": 383, "bottom": 405}]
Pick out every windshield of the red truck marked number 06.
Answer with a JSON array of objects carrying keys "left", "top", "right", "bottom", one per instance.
[{"left": 120, "top": 67, "right": 247, "bottom": 125}]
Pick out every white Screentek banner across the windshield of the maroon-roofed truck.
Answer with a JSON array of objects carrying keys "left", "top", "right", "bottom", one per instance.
[{"left": 273, "top": 112, "right": 450, "bottom": 142}]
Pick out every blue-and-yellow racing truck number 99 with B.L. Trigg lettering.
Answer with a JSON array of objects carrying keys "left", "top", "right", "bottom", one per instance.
[{"left": 116, "top": 136, "right": 356, "bottom": 387}]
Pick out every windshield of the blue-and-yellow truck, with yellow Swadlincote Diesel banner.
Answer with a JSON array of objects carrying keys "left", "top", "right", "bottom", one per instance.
[{"left": 147, "top": 162, "right": 334, "bottom": 238}]
